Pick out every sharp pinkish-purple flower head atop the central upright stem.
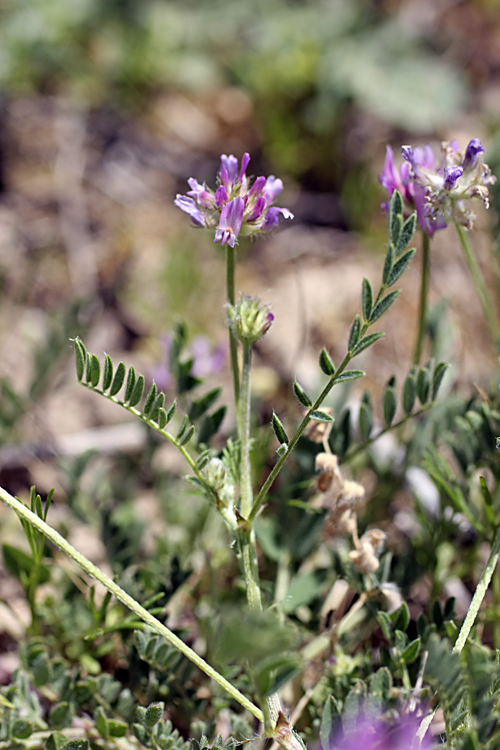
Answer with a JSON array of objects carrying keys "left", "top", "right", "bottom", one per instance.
[{"left": 174, "top": 153, "right": 293, "bottom": 247}]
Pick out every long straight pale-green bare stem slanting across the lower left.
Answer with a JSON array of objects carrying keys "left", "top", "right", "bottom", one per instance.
[{"left": 0, "top": 487, "right": 264, "bottom": 721}]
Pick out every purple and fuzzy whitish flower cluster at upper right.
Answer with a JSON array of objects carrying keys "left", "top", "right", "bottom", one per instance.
[{"left": 379, "top": 138, "right": 496, "bottom": 237}]
